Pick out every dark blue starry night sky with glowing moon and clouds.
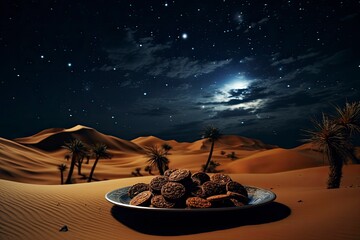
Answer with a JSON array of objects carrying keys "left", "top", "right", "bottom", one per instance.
[{"left": 0, "top": 0, "right": 360, "bottom": 147}]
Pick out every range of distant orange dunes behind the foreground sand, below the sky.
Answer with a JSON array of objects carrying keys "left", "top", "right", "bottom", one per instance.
[{"left": 0, "top": 125, "right": 352, "bottom": 184}]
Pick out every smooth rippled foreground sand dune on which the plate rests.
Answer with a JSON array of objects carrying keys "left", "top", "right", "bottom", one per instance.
[{"left": 0, "top": 165, "right": 360, "bottom": 240}]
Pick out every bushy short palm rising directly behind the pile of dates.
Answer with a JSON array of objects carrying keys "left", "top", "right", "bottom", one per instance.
[{"left": 145, "top": 145, "right": 169, "bottom": 175}]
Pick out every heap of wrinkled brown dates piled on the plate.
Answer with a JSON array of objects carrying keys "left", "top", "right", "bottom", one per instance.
[{"left": 128, "top": 169, "right": 249, "bottom": 208}]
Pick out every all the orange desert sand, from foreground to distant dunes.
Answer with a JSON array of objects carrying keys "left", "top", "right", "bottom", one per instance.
[{"left": 0, "top": 125, "right": 360, "bottom": 240}]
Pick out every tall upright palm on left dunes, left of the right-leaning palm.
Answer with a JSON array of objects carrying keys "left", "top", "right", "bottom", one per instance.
[{"left": 64, "top": 139, "right": 88, "bottom": 184}]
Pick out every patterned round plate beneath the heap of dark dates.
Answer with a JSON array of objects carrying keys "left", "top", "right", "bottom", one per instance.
[{"left": 105, "top": 186, "right": 276, "bottom": 212}]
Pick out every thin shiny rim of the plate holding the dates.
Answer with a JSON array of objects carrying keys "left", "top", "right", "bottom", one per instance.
[{"left": 105, "top": 185, "right": 277, "bottom": 212}]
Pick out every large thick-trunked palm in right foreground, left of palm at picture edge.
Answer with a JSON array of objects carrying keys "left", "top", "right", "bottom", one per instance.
[{"left": 305, "top": 113, "right": 350, "bottom": 188}]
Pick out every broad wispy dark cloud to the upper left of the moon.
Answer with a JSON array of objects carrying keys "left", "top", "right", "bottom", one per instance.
[{"left": 98, "top": 30, "right": 232, "bottom": 78}]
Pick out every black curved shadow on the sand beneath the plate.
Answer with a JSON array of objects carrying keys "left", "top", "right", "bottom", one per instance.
[{"left": 111, "top": 202, "right": 291, "bottom": 236}]
